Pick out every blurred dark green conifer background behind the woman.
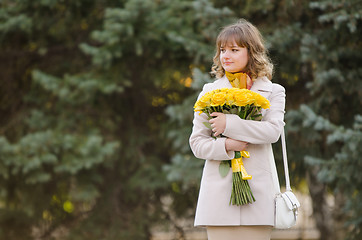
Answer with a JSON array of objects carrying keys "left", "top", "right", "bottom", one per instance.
[{"left": 0, "top": 0, "right": 362, "bottom": 240}]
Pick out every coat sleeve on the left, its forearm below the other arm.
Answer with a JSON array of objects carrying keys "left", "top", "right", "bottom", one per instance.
[{"left": 189, "top": 84, "right": 235, "bottom": 160}]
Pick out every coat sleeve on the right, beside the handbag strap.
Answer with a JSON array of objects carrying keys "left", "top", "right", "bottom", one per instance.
[{"left": 223, "top": 84, "right": 285, "bottom": 144}]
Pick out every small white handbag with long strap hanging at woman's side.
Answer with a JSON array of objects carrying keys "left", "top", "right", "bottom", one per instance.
[{"left": 275, "top": 129, "right": 300, "bottom": 229}]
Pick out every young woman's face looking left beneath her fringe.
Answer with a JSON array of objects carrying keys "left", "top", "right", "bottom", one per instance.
[{"left": 220, "top": 40, "right": 249, "bottom": 73}]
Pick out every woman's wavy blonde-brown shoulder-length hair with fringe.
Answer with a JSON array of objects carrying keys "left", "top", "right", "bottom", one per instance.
[{"left": 211, "top": 19, "right": 273, "bottom": 80}]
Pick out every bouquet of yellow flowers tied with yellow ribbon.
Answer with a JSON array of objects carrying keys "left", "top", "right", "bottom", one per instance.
[{"left": 194, "top": 88, "right": 270, "bottom": 205}]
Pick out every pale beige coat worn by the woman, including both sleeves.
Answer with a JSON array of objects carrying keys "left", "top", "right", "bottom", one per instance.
[{"left": 190, "top": 76, "right": 285, "bottom": 226}]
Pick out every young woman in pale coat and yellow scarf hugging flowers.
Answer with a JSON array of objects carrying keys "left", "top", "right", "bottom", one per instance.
[{"left": 190, "top": 19, "right": 285, "bottom": 240}]
